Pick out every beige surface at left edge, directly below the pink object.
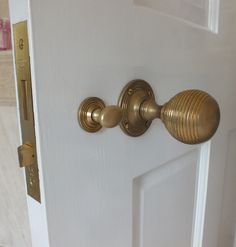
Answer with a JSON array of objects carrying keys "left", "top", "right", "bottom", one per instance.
[{"left": 0, "top": 51, "right": 16, "bottom": 106}]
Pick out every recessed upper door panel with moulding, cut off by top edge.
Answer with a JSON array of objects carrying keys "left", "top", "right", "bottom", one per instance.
[{"left": 134, "top": 0, "right": 220, "bottom": 33}]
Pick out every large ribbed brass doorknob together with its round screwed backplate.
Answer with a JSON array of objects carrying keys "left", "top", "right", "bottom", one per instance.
[{"left": 119, "top": 80, "right": 220, "bottom": 144}]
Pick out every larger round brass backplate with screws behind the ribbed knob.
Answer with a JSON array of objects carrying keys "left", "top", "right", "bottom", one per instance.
[{"left": 118, "top": 80, "right": 155, "bottom": 137}]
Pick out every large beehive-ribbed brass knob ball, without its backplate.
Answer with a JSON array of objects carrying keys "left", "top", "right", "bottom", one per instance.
[{"left": 160, "top": 90, "right": 220, "bottom": 144}]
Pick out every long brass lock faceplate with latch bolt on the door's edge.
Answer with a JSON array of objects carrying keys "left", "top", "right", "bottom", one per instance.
[{"left": 13, "top": 21, "right": 41, "bottom": 202}]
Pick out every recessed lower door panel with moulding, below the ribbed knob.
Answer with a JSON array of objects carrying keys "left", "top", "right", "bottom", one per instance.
[{"left": 133, "top": 142, "right": 211, "bottom": 247}]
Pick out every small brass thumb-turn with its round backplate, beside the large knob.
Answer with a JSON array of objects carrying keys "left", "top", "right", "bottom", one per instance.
[{"left": 78, "top": 97, "right": 122, "bottom": 133}]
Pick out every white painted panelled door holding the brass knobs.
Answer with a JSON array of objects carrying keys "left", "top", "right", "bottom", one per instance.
[{"left": 10, "top": 0, "right": 236, "bottom": 247}]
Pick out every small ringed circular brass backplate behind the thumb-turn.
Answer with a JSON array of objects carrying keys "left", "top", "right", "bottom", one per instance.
[{"left": 78, "top": 97, "right": 105, "bottom": 133}]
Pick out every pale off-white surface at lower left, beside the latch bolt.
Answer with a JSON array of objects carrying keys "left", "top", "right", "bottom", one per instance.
[{"left": 0, "top": 106, "right": 31, "bottom": 247}]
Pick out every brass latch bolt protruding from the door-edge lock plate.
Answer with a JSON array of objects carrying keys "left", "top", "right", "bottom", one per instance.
[{"left": 18, "top": 143, "right": 36, "bottom": 167}]
